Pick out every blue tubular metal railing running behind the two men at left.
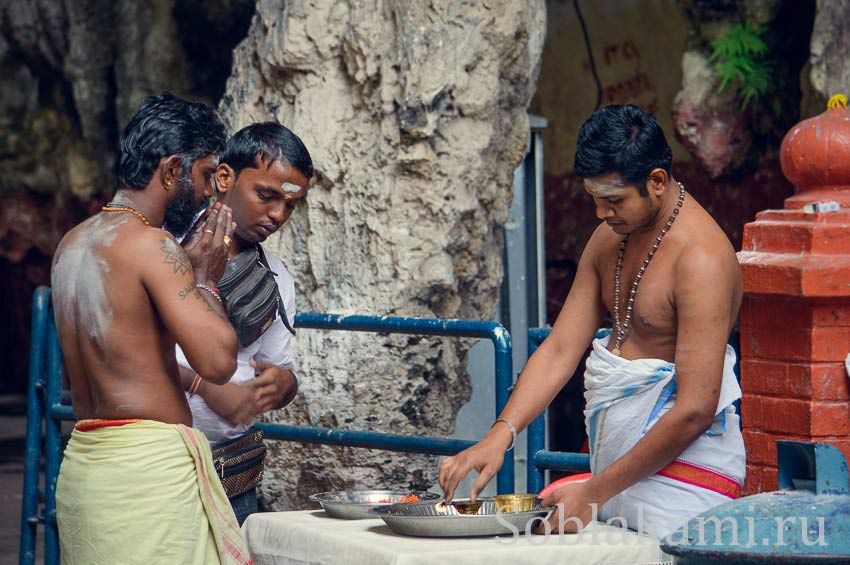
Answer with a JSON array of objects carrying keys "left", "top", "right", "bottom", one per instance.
[{"left": 20, "top": 287, "right": 515, "bottom": 565}]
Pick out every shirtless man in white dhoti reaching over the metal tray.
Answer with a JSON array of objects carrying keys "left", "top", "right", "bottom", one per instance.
[{"left": 439, "top": 105, "right": 745, "bottom": 536}]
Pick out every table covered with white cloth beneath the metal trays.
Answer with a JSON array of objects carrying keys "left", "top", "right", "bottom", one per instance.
[{"left": 242, "top": 510, "right": 670, "bottom": 565}]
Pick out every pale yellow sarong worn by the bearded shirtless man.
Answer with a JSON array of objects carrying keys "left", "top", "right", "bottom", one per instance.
[{"left": 56, "top": 420, "right": 251, "bottom": 565}]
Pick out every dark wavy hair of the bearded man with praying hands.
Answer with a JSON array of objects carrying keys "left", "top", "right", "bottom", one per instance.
[{"left": 116, "top": 92, "right": 227, "bottom": 189}]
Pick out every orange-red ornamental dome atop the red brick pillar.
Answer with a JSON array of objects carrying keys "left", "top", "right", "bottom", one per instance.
[{"left": 780, "top": 94, "right": 850, "bottom": 208}]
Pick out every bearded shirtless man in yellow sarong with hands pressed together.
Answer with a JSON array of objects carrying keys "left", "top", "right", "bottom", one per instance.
[{"left": 52, "top": 93, "right": 247, "bottom": 564}]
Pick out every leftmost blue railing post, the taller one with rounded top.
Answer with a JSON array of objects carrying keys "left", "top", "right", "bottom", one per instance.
[{"left": 18, "top": 286, "right": 50, "bottom": 565}]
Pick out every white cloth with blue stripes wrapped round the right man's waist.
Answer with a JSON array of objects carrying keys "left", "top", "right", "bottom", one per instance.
[{"left": 584, "top": 333, "right": 746, "bottom": 537}]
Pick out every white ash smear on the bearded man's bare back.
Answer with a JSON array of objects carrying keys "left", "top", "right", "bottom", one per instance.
[{"left": 51, "top": 215, "right": 127, "bottom": 344}]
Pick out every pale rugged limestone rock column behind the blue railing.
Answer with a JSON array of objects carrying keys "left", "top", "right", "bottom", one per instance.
[{"left": 220, "top": 0, "right": 545, "bottom": 509}]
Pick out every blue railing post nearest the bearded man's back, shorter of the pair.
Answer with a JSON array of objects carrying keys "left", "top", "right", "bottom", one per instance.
[{"left": 44, "top": 320, "right": 62, "bottom": 563}]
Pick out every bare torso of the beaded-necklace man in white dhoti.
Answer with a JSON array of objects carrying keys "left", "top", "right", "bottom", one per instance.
[{"left": 585, "top": 189, "right": 742, "bottom": 363}]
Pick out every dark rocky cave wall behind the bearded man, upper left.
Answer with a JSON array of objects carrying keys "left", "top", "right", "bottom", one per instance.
[{"left": 0, "top": 0, "right": 254, "bottom": 394}]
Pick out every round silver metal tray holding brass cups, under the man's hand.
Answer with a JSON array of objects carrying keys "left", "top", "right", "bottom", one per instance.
[{"left": 369, "top": 499, "right": 553, "bottom": 538}]
